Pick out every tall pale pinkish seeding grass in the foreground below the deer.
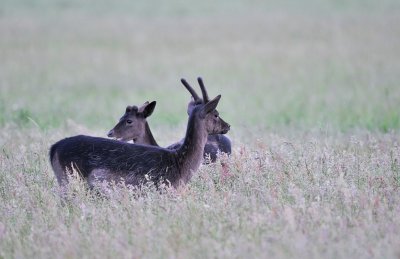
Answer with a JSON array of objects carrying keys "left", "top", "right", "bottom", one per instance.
[{"left": 0, "top": 130, "right": 400, "bottom": 258}]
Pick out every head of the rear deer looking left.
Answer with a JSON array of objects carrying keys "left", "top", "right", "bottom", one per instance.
[{"left": 107, "top": 101, "right": 156, "bottom": 142}]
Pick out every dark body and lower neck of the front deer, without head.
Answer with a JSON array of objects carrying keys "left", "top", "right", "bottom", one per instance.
[{"left": 51, "top": 112, "right": 207, "bottom": 187}]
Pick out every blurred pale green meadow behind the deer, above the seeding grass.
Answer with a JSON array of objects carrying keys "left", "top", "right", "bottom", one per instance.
[{"left": 0, "top": 0, "right": 400, "bottom": 132}]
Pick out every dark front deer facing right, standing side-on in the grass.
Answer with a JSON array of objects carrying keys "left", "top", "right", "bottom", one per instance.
[{"left": 50, "top": 77, "right": 230, "bottom": 188}]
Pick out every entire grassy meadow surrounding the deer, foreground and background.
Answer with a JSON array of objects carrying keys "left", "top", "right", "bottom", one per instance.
[{"left": 0, "top": 0, "right": 400, "bottom": 258}]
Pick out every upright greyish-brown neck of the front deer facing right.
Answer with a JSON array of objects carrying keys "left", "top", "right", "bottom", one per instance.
[{"left": 177, "top": 116, "right": 208, "bottom": 182}]
